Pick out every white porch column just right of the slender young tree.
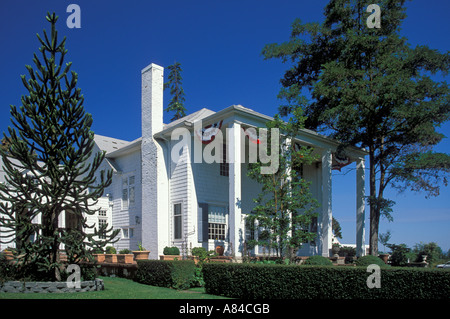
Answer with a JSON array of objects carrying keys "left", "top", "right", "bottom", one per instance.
[{"left": 319, "top": 150, "right": 333, "bottom": 257}]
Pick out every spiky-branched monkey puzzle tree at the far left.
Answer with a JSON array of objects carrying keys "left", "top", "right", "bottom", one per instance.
[{"left": 0, "top": 13, "right": 117, "bottom": 280}]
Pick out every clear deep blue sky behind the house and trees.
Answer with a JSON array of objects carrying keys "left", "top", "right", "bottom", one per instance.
[{"left": 0, "top": 0, "right": 450, "bottom": 251}]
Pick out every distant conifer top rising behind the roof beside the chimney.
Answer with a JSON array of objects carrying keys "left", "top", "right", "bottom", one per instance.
[{"left": 164, "top": 62, "right": 186, "bottom": 121}]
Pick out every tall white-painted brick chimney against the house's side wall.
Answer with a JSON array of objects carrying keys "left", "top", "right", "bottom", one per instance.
[{"left": 141, "top": 63, "right": 170, "bottom": 259}]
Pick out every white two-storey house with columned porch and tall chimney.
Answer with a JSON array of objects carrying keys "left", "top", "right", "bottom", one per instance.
[{"left": 0, "top": 64, "right": 367, "bottom": 259}]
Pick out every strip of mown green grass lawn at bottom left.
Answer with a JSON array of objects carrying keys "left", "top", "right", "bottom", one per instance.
[{"left": 0, "top": 277, "right": 229, "bottom": 299}]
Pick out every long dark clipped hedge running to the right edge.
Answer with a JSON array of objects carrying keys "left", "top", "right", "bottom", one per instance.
[{"left": 203, "top": 264, "right": 450, "bottom": 299}]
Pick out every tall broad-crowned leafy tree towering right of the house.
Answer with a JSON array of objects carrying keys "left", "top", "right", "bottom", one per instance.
[{"left": 263, "top": 0, "right": 450, "bottom": 255}]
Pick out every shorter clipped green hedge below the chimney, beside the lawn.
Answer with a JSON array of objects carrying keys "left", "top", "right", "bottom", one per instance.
[{"left": 134, "top": 260, "right": 195, "bottom": 289}]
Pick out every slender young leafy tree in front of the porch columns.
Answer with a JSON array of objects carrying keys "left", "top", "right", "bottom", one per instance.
[{"left": 246, "top": 112, "right": 318, "bottom": 259}]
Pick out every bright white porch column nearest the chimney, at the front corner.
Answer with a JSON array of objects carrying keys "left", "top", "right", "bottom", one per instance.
[{"left": 227, "top": 123, "right": 245, "bottom": 257}]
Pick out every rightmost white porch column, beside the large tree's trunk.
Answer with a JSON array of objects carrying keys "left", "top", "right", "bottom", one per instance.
[{"left": 356, "top": 158, "right": 366, "bottom": 257}]
